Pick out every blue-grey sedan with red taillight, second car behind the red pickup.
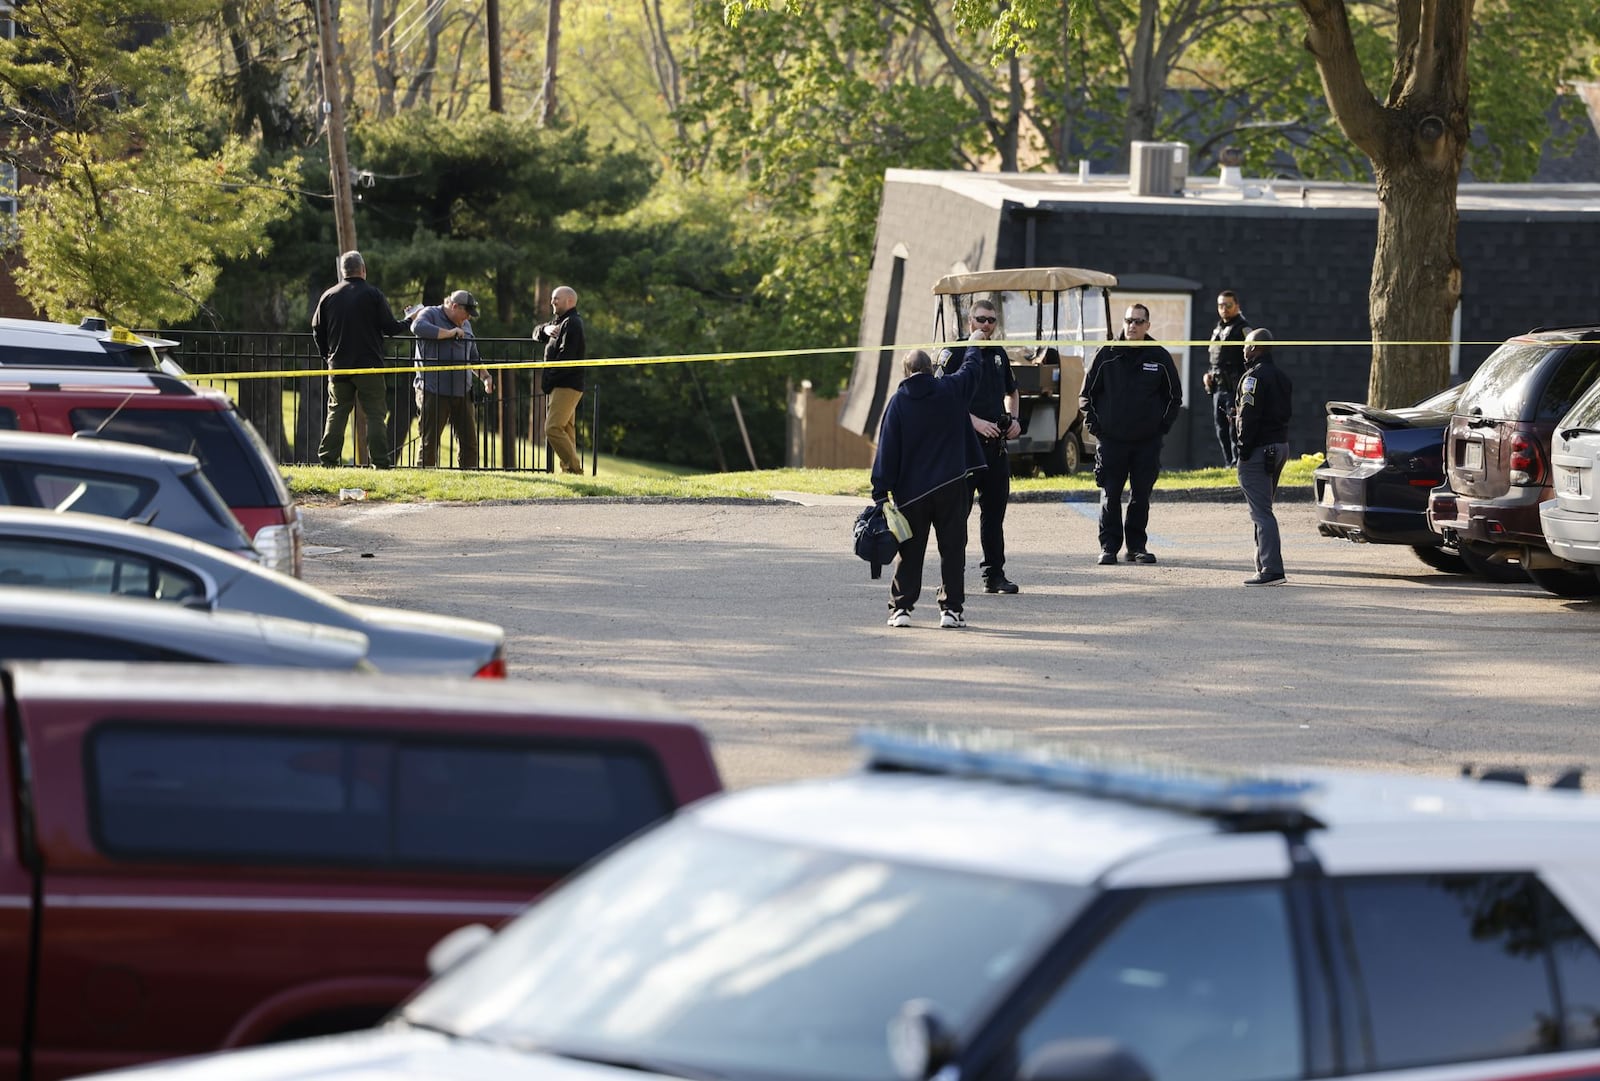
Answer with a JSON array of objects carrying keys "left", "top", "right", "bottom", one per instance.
[{"left": 0, "top": 507, "right": 506, "bottom": 678}]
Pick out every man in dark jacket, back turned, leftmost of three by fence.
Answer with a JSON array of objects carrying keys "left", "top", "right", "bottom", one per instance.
[{"left": 310, "top": 251, "right": 411, "bottom": 469}]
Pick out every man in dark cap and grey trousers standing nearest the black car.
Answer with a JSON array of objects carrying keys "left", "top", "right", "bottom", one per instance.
[{"left": 1237, "top": 329, "right": 1294, "bottom": 585}]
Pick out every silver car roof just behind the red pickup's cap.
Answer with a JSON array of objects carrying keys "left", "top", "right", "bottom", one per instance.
[{"left": 0, "top": 585, "right": 366, "bottom": 668}]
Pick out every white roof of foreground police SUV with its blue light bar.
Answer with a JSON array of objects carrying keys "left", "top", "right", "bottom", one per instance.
[{"left": 696, "top": 734, "right": 1600, "bottom": 886}]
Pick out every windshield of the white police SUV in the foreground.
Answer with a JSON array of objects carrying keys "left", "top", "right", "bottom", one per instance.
[{"left": 403, "top": 819, "right": 1086, "bottom": 1081}]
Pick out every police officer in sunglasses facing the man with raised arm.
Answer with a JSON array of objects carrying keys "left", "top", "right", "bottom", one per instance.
[{"left": 936, "top": 301, "right": 1022, "bottom": 593}]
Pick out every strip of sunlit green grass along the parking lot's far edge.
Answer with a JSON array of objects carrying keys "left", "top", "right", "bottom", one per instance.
[{"left": 285, "top": 454, "right": 1322, "bottom": 502}]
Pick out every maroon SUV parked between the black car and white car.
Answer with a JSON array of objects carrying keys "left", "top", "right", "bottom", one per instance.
[{"left": 1427, "top": 325, "right": 1600, "bottom": 596}]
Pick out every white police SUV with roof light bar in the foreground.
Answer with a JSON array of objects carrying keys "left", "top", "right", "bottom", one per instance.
[{"left": 75, "top": 725, "right": 1600, "bottom": 1081}]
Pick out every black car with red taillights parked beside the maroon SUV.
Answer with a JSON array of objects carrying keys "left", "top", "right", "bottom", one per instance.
[{"left": 1312, "top": 385, "right": 1467, "bottom": 574}]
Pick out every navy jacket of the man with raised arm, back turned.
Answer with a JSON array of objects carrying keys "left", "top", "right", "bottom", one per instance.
[{"left": 872, "top": 350, "right": 987, "bottom": 507}]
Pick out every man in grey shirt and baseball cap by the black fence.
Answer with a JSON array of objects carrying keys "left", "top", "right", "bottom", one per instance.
[{"left": 411, "top": 289, "right": 494, "bottom": 469}]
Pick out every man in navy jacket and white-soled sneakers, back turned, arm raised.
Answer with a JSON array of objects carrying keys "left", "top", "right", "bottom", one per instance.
[{"left": 872, "top": 347, "right": 986, "bottom": 630}]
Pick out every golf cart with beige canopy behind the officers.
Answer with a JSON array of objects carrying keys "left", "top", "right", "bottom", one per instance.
[{"left": 933, "top": 267, "right": 1117, "bottom": 477}]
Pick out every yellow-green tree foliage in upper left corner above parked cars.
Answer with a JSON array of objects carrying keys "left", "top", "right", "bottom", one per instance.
[{"left": 0, "top": 0, "right": 296, "bottom": 326}]
